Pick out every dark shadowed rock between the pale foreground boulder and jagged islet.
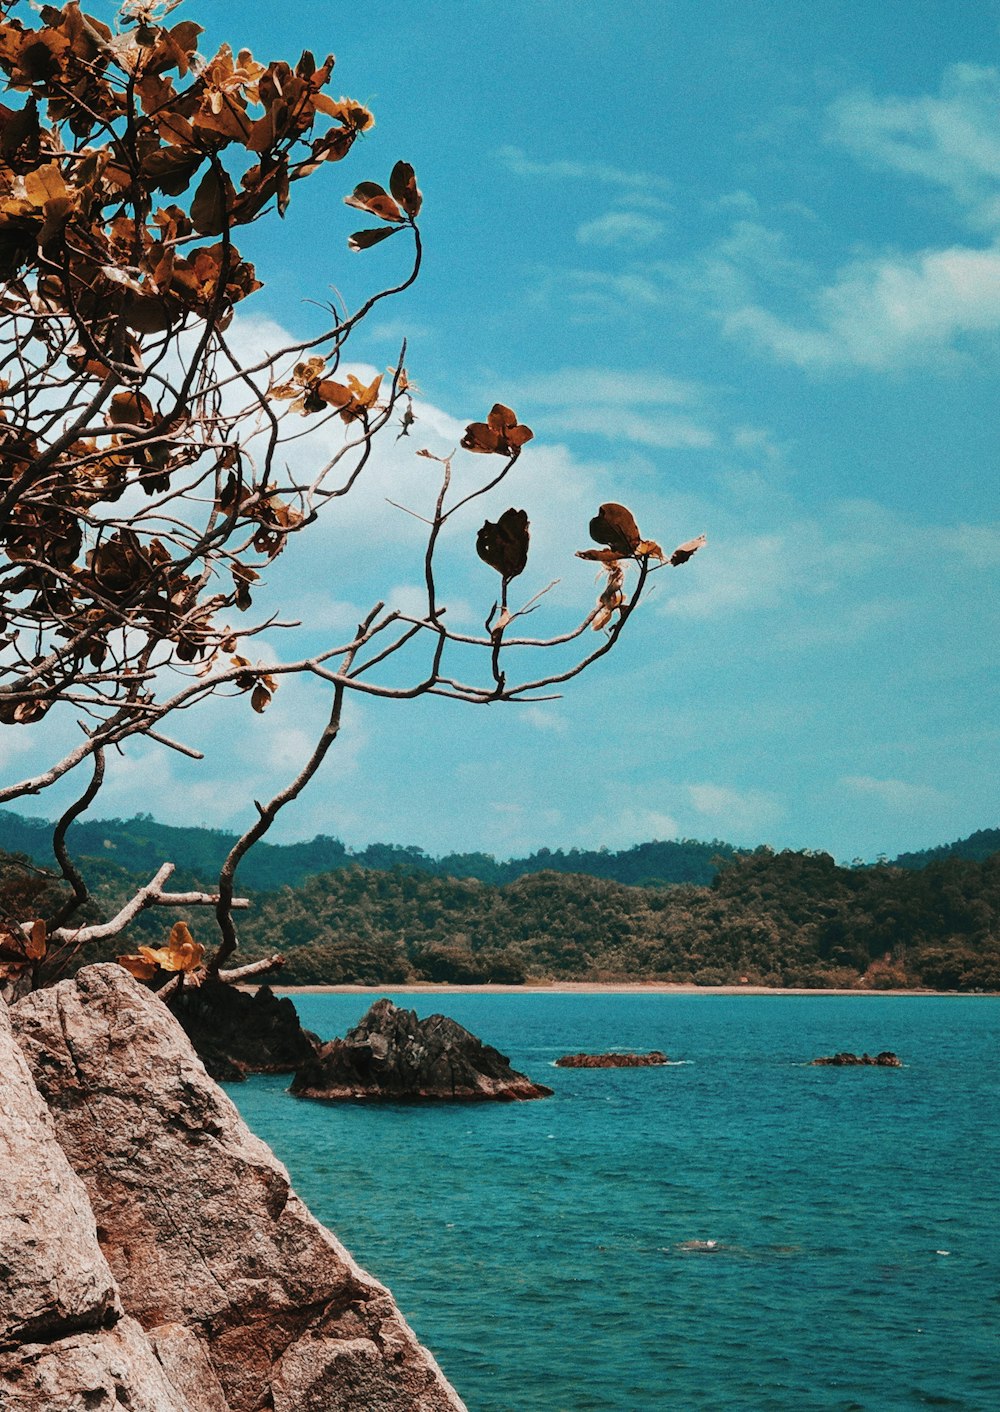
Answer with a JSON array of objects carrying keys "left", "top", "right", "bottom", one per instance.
[{"left": 169, "top": 981, "right": 319, "bottom": 1082}]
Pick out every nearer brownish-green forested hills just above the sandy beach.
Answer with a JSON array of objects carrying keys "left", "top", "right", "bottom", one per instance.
[{"left": 0, "top": 830, "right": 1000, "bottom": 990}]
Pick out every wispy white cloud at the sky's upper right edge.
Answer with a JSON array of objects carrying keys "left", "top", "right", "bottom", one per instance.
[{"left": 662, "top": 65, "right": 1000, "bottom": 371}]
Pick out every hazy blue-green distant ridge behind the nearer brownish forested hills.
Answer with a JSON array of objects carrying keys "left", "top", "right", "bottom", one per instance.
[{"left": 0, "top": 809, "right": 1000, "bottom": 891}]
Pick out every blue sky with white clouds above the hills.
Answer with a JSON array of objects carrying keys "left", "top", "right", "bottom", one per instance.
[{"left": 9, "top": 0, "right": 1000, "bottom": 860}]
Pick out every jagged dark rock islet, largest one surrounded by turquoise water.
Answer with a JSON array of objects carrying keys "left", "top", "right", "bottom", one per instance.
[{"left": 291, "top": 1000, "right": 552, "bottom": 1101}]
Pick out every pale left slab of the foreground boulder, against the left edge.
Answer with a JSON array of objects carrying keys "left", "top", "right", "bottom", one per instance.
[{"left": 0, "top": 1001, "right": 194, "bottom": 1412}]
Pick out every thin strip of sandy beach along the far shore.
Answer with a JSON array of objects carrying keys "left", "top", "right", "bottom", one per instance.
[{"left": 265, "top": 980, "right": 997, "bottom": 1000}]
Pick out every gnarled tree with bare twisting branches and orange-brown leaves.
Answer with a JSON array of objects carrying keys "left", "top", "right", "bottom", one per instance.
[{"left": 0, "top": 0, "right": 702, "bottom": 984}]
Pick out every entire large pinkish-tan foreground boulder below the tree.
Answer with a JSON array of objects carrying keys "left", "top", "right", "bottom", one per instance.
[{"left": 0, "top": 966, "right": 465, "bottom": 1412}]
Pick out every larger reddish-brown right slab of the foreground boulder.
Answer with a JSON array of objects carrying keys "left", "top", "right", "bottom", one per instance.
[{"left": 13, "top": 964, "right": 463, "bottom": 1412}]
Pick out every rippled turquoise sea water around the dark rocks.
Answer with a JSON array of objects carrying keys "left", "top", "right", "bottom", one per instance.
[{"left": 229, "top": 991, "right": 1000, "bottom": 1412}]
